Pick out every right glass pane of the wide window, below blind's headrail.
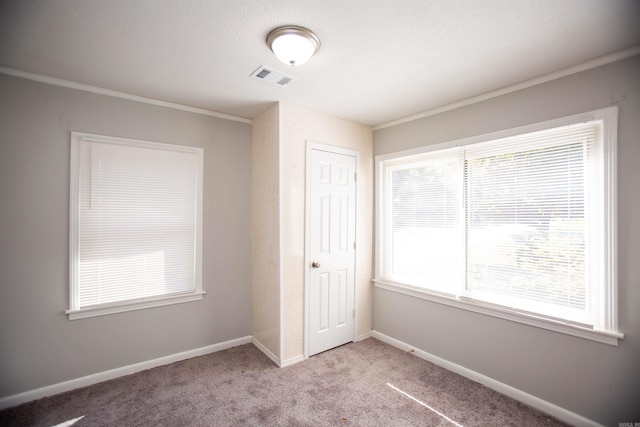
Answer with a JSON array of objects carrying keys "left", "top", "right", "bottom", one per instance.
[{"left": 465, "top": 143, "right": 588, "bottom": 310}]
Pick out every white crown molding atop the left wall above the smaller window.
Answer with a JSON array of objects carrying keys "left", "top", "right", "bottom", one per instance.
[{"left": 0, "top": 66, "right": 251, "bottom": 124}]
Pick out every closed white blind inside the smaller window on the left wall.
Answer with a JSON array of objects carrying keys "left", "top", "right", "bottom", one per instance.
[{"left": 79, "top": 141, "right": 198, "bottom": 308}]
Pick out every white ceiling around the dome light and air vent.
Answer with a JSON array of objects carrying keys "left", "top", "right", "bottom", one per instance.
[{"left": 0, "top": 0, "right": 640, "bottom": 126}]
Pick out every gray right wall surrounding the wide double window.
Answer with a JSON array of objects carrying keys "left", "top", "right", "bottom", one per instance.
[{"left": 373, "top": 56, "right": 640, "bottom": 426}]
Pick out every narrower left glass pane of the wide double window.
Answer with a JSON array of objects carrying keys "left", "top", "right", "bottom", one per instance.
[{"left": 388, "top": 155, "right": 464, "bottom": 293}]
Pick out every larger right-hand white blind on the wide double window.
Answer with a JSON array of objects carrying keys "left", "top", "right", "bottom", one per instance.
[{"left": 464, "top": 122, "right": 600, "bottom": 323}]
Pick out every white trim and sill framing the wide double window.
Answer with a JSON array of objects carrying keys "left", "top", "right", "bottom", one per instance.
[{"left": 373, "top": 106, "right": 624, "bottom": 346}]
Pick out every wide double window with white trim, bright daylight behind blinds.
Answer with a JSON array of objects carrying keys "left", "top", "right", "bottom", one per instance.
[{"left": 376, "top": 108, "right": 622, "bottom": 344}]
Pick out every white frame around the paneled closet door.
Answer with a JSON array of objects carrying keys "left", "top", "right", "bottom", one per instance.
[{"left": 303, "top": 140, "right": 360, "bottom": 360}]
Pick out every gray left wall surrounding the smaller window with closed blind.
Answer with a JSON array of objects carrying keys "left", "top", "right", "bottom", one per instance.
[{"left": 0, "top": 74, "right": 251, "bottom": 397}]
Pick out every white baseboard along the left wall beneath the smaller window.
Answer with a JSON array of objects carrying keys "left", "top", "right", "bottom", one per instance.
[{"left": 0, "top": 336, "right": 251, "bottom": 410}]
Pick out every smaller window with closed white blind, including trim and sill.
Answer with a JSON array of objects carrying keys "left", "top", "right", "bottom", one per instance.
[{"left": 67, "top": 132, "right": 204, "bottom": 320}]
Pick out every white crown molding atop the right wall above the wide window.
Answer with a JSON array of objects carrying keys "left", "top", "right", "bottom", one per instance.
[{"left": 372, "top": 45, "right": 640, "bottom": 131}]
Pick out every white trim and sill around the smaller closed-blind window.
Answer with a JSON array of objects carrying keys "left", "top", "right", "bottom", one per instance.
[{"left": 65, "top": 132, "right": 206, "bottom": 320}]
